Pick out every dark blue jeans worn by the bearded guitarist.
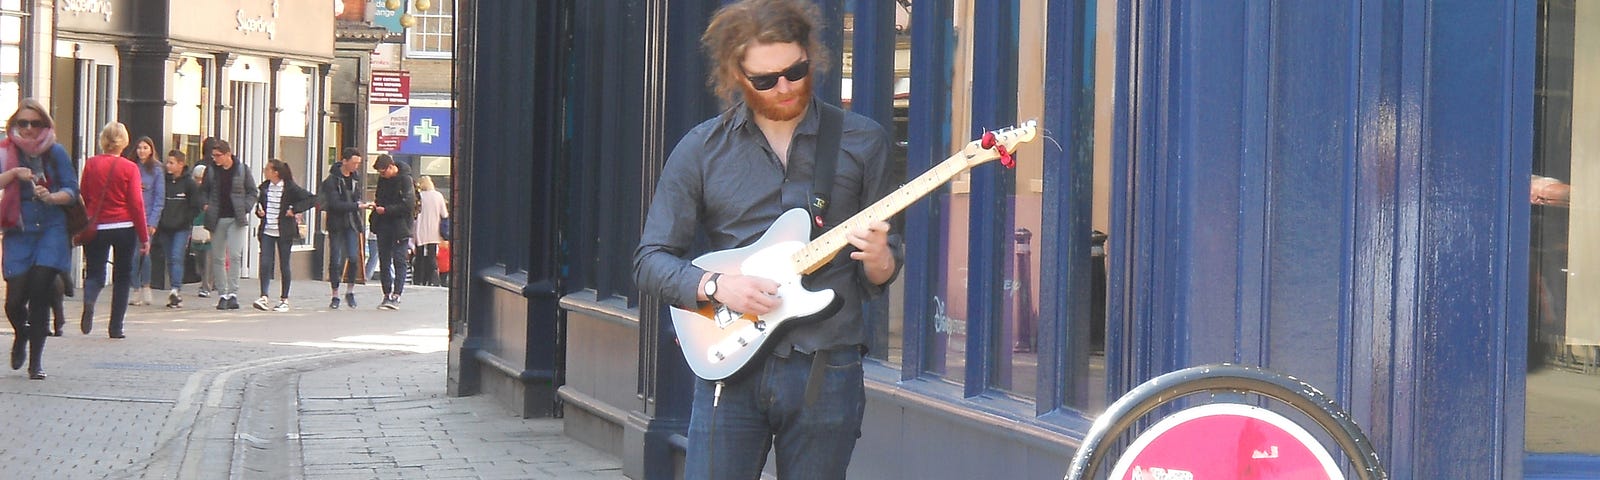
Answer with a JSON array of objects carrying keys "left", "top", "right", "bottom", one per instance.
[{"left": 683, "top": 347, "right": 866, "bottom": 480}]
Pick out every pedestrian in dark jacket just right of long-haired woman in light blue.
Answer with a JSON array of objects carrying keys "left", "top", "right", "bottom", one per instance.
[{"left": 155, "top": 150, "right": 200, "bottom": 309}]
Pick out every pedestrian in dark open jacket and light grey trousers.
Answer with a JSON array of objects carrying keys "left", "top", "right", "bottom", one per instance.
[{"left": 202, "top": 139, "right": 258, "bottom": 310}]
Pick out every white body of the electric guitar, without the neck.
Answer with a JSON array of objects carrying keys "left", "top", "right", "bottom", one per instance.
[{"left": 672, "top": 208, "right": 837, "bottom": 381}]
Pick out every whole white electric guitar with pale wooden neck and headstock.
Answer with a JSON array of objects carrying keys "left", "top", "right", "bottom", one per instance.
[{"left": 670, "top": 120, "right": 1038, "bottom": 381}]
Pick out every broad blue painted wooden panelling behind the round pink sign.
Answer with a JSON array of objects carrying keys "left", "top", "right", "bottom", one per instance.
[{"left": 1110, "top": 0, "right": 1534, "bottom": 478}]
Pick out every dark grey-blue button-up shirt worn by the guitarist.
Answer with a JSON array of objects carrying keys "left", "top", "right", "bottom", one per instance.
[{"left": 634, "top": 99, "right": 902, "bottom": 355}]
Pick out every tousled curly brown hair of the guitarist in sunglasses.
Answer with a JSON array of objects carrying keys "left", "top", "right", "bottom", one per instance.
[{"left": 701, "top": 0, "right": 829, "bottom": 104}]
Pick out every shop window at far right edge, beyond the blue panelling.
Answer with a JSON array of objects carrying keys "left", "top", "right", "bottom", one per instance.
[{"left": 1526, "top": 0, "right": 1600, "bottom": 454}]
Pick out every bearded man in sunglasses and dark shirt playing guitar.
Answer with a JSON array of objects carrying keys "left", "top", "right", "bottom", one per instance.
[{"left": 634, "top": 0, "right": 901, "bottom": 478}]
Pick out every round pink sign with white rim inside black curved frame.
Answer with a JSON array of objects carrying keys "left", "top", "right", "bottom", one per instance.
[{"left": 1110, "top": 403, "right": 1344, "bottom": 480}]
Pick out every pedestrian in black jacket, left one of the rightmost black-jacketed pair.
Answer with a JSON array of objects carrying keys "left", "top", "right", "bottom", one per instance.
[{"left": 317, "top": 147, "right": 366, "bottom": 310}]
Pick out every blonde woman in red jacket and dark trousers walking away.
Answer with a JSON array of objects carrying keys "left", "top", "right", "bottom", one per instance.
[{"left": 78, "top": 122, "right": 150, "bottom": 338}]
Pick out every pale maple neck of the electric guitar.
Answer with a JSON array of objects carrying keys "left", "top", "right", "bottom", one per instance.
[{"left": 794, "top": 149, "right": 987, "bottom": 274}]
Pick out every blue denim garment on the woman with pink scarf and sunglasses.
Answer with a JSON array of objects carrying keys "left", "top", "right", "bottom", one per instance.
[{"left": 0, "top": 144, "right": 78, "bottom": 278}]
